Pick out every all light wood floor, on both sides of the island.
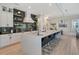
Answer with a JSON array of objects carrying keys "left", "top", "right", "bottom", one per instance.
[{"left": 0, "top": 35, "right": 79, "bottom": 55}]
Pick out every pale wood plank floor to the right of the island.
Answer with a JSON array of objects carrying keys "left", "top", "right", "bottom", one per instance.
[{"left": 51, "top": 35, "right": 79, "bottom": 55}]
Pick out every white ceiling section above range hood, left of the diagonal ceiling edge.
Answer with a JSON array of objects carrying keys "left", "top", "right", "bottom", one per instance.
[{"left": 18, "top": 3, "right": 62, "bottom": 17}]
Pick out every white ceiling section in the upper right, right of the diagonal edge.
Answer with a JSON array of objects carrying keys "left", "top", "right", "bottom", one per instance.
[{"left": 58, "top": 3, "right": 79, "bottom": 15}]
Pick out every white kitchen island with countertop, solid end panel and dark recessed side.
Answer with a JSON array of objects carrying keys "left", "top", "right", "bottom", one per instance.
[{"left": 21, "top": 30, "right": 61, "bottom": 55}]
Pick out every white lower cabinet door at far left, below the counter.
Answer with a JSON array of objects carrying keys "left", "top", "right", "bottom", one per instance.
[{"left": 0, "top": 35, "right": 9, "bottom": 48}]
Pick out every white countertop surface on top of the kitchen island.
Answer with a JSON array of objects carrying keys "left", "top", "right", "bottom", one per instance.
[{"left": 23, "top": 30, "right": 60, "bottom": 37}]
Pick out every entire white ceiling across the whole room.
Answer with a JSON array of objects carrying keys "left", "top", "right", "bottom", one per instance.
[{"left": 0, "top": 3, "right": 79, "bottom": 17}]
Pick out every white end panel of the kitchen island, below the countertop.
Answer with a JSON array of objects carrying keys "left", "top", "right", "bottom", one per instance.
[{"left": 21, "top": 36, "right": 42, "bottom": 55}]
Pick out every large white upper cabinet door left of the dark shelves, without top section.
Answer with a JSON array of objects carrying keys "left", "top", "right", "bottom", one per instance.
[{"left": 0, "top": 11, "right": 13, "bottom": 27}]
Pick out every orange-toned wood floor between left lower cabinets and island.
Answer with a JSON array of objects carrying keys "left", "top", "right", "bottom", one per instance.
[{"left": 0, "top": 43, "right": 22, "bottom": 55}]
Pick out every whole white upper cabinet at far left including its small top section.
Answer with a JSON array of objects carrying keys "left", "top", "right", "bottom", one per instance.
[{"left": 0, "top": 6, "right": 13, "bottom": 27}]
